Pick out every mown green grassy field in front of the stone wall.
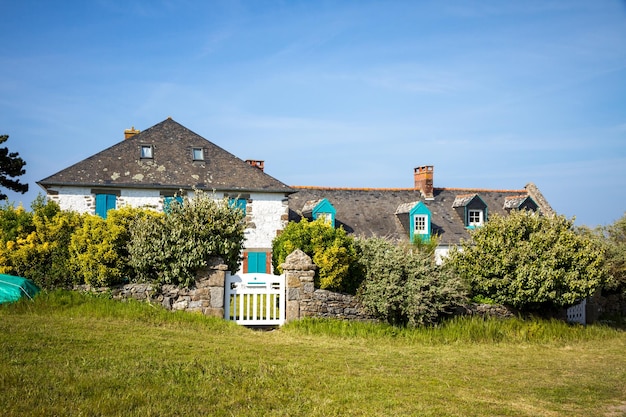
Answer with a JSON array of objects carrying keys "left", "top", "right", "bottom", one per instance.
[{"left": 0, "top": 292, "right": 626, "bottom": 416}]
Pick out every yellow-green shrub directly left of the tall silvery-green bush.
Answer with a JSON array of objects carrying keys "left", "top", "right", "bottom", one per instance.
[{"left": 70, "top": 207, "right": 162, "bottom": 287}]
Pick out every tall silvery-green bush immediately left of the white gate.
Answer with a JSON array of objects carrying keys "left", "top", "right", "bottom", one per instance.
[{"left": 128, "top": 191, "right": 245, "bottom": 286}]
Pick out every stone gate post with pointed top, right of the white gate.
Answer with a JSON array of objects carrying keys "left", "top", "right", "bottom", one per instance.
[{"left": 281, "top": 249, "right": 317, "bottom": 322}]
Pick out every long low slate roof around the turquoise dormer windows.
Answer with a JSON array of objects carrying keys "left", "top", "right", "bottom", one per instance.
[{"left": 289, "top": 186, "right": 540, "bottom": 245}]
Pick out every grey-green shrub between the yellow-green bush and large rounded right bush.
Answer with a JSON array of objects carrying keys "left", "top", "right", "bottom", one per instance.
[{"left": 357, "top": 238, "right": 466, "bottom": 327}]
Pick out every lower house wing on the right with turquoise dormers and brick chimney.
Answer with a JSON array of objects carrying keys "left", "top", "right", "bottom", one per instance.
[{"left": 289, "top": 165, "right": 552, "bottom": 262}]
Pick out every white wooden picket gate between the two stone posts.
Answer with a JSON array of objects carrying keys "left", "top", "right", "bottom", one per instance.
[{"left": 224, "top": 273, "right": 285, "bottom": 326}]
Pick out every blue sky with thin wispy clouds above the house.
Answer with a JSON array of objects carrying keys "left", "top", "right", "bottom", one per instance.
[{"left": 0, "top": 0, "right": 626, "bottom": 226}]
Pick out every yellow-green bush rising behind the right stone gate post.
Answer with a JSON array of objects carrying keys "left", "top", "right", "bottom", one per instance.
[{"left": 272, "top": 218, "right": 362, "bottom": 294}]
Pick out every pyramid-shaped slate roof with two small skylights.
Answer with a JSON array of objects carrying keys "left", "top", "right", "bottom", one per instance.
[{"left": 38, "top": 118, "right": 294, "bottom": 193}]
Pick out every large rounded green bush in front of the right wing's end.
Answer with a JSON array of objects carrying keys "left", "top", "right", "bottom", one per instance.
[{"left": 448, "top": 210, "right": 606, "bottom": 310}]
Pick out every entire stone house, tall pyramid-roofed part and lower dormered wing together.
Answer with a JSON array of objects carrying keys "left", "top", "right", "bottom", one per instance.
[{"left": 38, "top": 118, "right": 552, "bottom": 272}]
